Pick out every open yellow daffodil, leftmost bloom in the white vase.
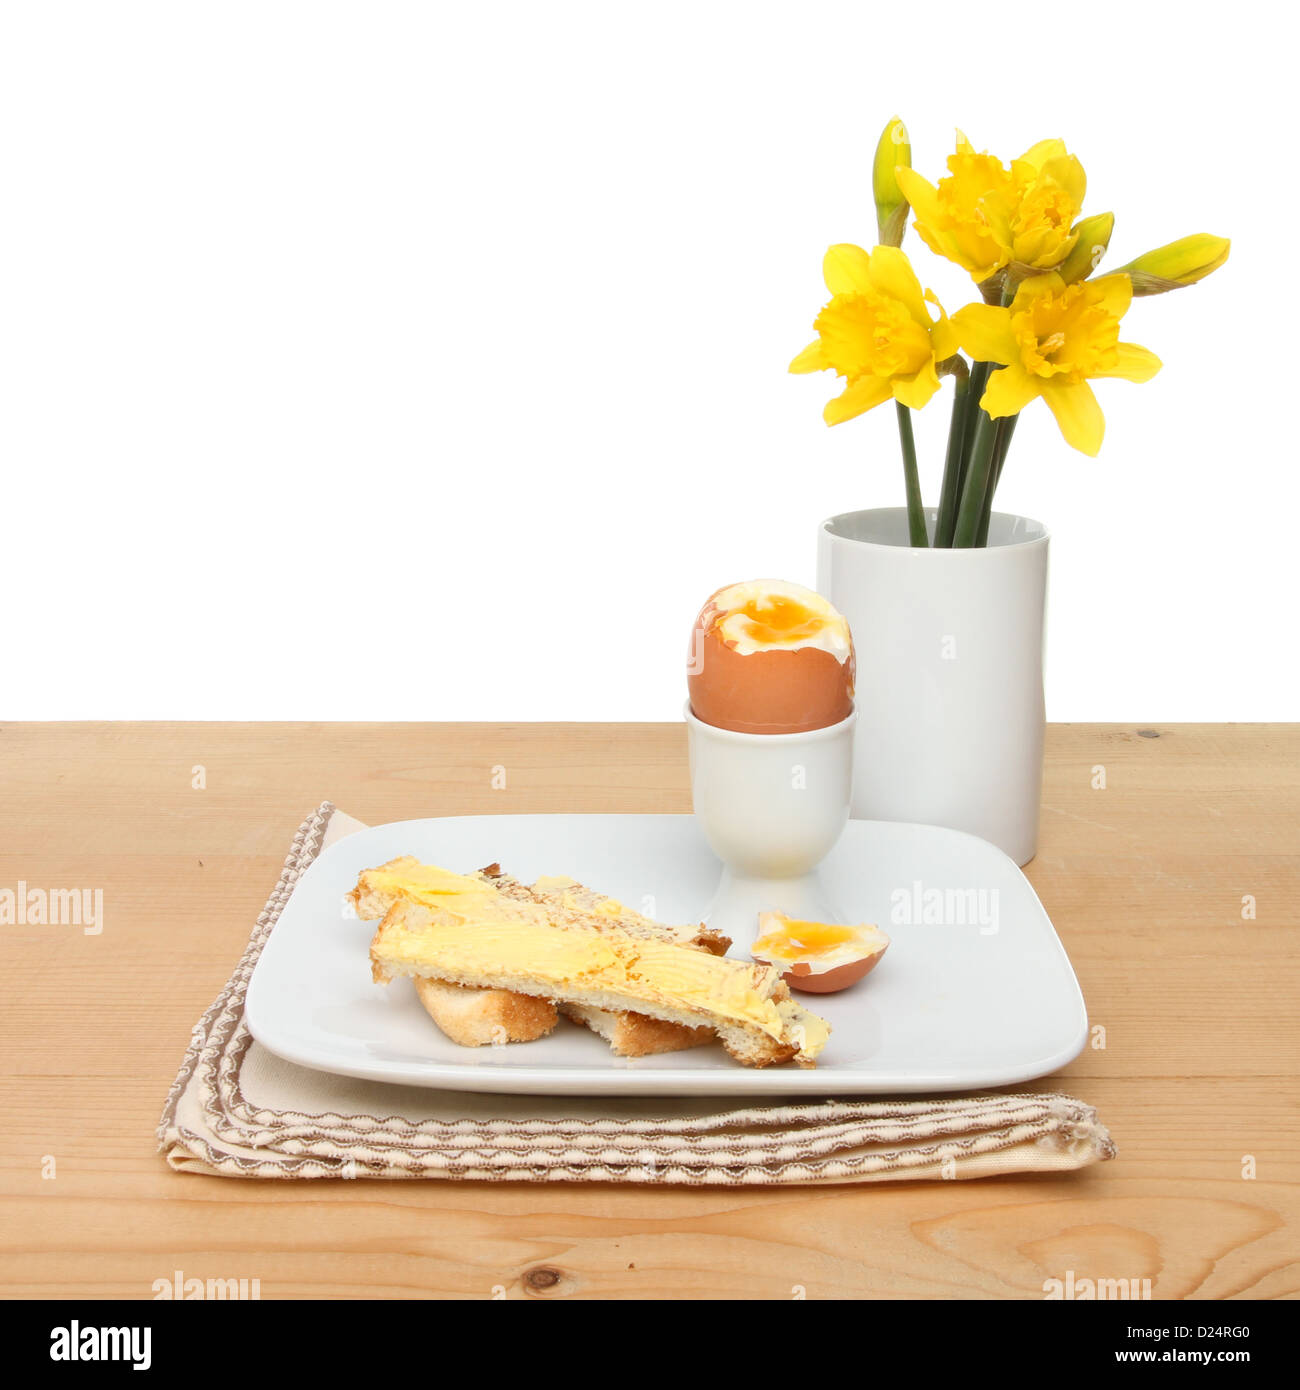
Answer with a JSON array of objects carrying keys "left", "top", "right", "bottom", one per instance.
[{"left": 790, "top": 245, "right": 957, "bottom": 425}]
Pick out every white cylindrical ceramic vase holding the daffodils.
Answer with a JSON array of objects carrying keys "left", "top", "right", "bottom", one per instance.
[{"left": 818, "top": 507, "right": 1048, "bottom": 865}]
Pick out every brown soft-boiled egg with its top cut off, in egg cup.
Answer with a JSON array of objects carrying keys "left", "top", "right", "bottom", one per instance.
[{"left": 687, "top": 580, "right": 855, "bottom": 734}]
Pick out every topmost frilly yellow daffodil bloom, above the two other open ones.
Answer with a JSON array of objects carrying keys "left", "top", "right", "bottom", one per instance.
[{"left": 895, "top": 132, "right": 1087, "bottom": 284}]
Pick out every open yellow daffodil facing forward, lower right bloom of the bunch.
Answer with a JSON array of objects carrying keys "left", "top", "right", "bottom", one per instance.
[{"left": 952, "top": 274, "right": 1160, "bottom": 455}]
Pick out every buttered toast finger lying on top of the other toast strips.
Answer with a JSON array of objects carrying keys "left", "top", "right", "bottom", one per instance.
[{"left": 370, "top": 880, "right": 830, "bottom": 1066}]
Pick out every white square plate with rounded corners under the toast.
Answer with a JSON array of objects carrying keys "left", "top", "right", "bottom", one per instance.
[{"left": 245, "top": 816, "right": 1087, "bottom": 1097}]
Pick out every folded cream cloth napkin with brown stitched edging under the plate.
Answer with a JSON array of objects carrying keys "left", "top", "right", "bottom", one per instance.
[{"left": 159, "top": 802, "right": 1115, "bottom": 1187}]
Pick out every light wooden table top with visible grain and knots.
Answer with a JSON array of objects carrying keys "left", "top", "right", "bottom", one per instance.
[{"left": 0, "top": 724, "right": 1300, "bottom": 1298}]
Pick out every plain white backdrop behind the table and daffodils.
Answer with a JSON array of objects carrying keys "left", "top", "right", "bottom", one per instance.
[{"left": 0, "top": 0, "right": 1300, "bottom": 720}]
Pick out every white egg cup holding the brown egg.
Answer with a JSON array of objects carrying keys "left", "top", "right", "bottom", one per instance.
[{"left": 685, "top": 703, "right": 858, "bottom": 948}]
